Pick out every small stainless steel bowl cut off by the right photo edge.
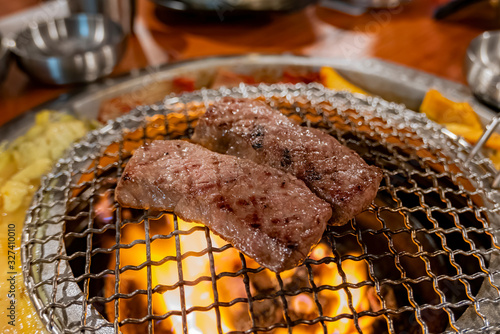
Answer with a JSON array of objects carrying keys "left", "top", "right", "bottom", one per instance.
[{"left": 465, "top": 31, "right": 500, "bottom": 110}]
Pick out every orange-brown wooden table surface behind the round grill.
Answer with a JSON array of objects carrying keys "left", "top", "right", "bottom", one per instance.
[{"left": 0, "top": 0, "right": 483, "bottom": 125}]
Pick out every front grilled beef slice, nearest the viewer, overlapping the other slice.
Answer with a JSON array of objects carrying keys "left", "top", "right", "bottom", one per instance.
[{"left": 115, "top": 140, "right": 331, "bottom": 272}]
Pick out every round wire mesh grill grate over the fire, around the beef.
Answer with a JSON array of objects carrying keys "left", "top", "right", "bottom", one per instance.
[{"left": 23, "top": 84, "right": 500, "bottom": 333}]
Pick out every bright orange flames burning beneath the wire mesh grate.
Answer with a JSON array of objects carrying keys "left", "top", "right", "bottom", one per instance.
[{"left": 103, "top": 210, "right": 376, "bottom": 334}]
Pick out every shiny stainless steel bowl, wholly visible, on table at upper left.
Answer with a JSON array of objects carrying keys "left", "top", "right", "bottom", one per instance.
[{"left": 11, "top": 14, "right": 127, "bottom": 85}]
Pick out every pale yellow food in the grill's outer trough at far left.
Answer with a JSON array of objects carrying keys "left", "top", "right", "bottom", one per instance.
[{"left": 0, "top": 110, "right": 92, "bottom": 334}]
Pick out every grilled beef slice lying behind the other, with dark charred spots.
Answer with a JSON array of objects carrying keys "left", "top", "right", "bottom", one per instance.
[{"left": 193, "top": 98, "right": 382, "bottom": 225}]
